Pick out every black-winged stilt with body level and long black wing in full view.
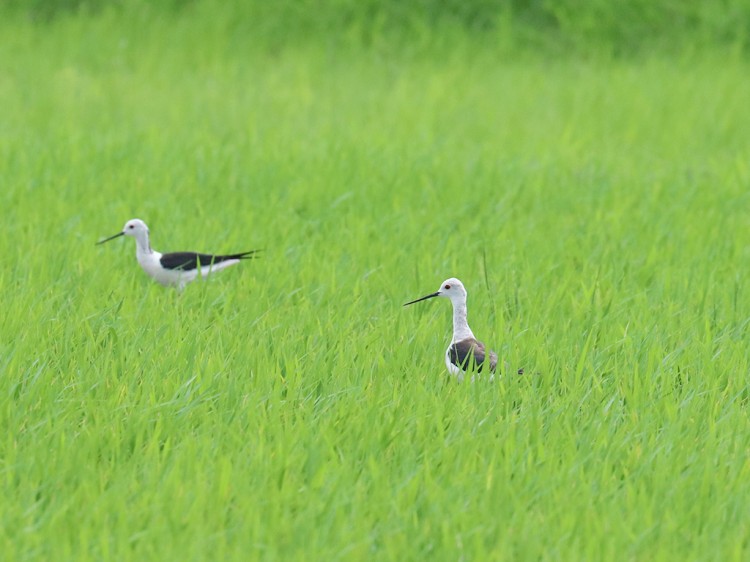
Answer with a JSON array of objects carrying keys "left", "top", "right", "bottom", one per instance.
[{"left": 97, "top": 219, "right": 258, "bottom": 290}]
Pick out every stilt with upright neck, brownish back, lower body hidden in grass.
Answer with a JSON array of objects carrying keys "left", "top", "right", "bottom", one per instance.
[{"left": 404, "top": 277, "right": 523, "bottom": 382}]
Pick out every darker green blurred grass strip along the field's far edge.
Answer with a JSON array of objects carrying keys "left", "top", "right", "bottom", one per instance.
[{"left": 0, "top": 0, "right": 750, "bottom": 57}]
